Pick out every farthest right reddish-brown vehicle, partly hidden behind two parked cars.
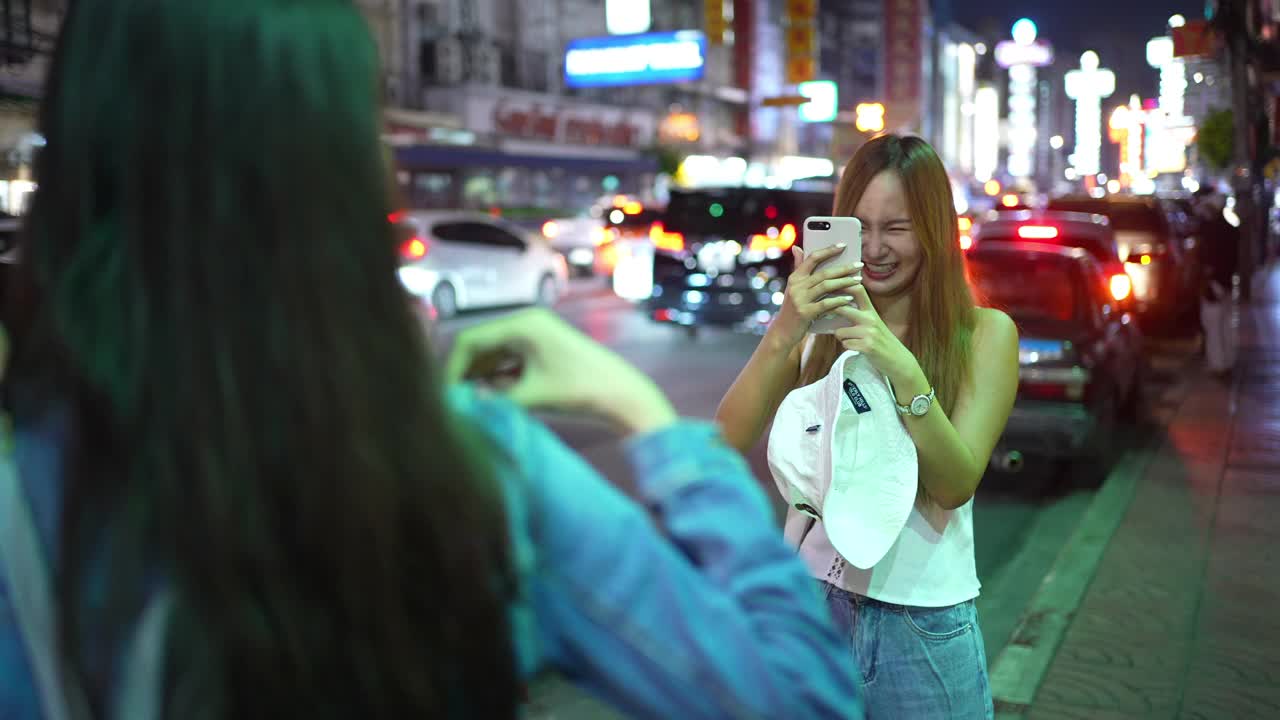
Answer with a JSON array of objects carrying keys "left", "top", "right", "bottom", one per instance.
[{"left": 1048, "top": 195, "right": 1199, "bottom": 323}]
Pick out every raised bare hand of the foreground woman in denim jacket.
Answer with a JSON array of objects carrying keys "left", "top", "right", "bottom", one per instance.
[{"left": 445, "top": 307, "right": 676, "bottom": 433}]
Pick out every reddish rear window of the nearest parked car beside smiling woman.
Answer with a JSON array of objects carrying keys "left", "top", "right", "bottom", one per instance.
[{"left": 968, "top": 252, "right": 1085, "bottom": 323}]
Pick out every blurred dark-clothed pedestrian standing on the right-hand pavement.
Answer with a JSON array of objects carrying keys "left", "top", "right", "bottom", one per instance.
[{"left": 1194, "top": 186, "right": 1240, "bottom": 379}]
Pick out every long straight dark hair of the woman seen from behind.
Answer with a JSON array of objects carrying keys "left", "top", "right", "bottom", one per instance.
[{"left": 6, "top": 0, "right": 518, "bottom": 717}]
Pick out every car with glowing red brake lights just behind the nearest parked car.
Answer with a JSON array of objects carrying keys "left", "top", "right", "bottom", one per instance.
[{"left": 961, "top": 210, "right": 1134, "bottom": 310}]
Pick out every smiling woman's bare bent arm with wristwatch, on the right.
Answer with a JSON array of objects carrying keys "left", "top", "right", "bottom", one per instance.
[{"left": 893, "top": 307, "right": 1018, "bottom": 509}]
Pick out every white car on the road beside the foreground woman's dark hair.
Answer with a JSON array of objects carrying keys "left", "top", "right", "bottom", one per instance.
[{"left": 390, "top": 210, "right": 568, "bottom": 319}]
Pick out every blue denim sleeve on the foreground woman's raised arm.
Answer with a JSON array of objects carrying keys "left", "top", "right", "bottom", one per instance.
[{"left": 451, "top": 388, "right": 863, "bottom": 720}]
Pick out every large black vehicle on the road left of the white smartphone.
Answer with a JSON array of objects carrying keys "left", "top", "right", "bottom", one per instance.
[{"left": 646, "top": 187, "right": 833, "bottom": 336}]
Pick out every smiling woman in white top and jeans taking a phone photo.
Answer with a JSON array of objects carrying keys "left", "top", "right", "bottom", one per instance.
[{"left": 716, "top": 135, "right": 1018, "bottom": 719}]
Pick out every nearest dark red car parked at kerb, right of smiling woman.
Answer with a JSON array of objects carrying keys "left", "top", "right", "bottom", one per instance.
[{"left": 966, "top": 241, "right": 1144, "bottom": 474}]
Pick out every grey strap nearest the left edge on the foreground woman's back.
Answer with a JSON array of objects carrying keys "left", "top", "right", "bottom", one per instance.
[{"left": 0, "top": 437, "right": 90, "bottom": 720}]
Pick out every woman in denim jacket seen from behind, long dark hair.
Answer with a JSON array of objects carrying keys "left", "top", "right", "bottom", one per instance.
[{"left": 0, "top": 0, "right": 859, "bottom": 720}]
